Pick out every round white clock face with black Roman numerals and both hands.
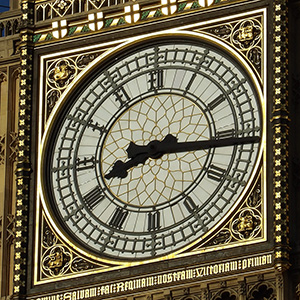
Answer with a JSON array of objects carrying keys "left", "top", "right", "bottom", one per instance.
[{"left": 41, "top": 38, "right": 263, "bottom": 261}]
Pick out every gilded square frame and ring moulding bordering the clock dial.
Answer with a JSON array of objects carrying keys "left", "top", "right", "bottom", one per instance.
[{"left": 34, "top": 9, "right": 267, "bottom": 284}]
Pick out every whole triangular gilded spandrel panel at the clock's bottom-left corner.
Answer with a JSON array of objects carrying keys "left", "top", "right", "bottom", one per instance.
[{"left": 40, "top": 218, "right": 107, "bottom": 279}]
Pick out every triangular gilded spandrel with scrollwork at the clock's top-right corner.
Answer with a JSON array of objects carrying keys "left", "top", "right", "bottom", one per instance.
[{"left": 197, "top": 16, "right": 262, "bottom": 75}]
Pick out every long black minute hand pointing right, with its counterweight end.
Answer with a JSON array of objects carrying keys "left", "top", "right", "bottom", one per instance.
[{"left": 126, "top": 134, "right": 260, "bottom": 158}]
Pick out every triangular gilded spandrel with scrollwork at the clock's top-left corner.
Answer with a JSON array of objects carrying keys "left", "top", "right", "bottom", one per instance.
[{"left": 46, "top": 52, "right": 101, "bottom": 117}]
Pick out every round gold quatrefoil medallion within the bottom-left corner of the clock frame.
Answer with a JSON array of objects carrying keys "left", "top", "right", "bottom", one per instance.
[{"left": 42, "top": 244, "right": 72, "bottom": 277}]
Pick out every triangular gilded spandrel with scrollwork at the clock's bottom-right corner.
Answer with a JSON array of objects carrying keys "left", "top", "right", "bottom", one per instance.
[{"left": 201, "top": 179, "right": 263, "bottom": 247}]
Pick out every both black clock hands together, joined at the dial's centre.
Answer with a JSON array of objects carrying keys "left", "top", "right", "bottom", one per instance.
[{"left": 104, "top": 134, "right": 260, "bottom": 179}]
